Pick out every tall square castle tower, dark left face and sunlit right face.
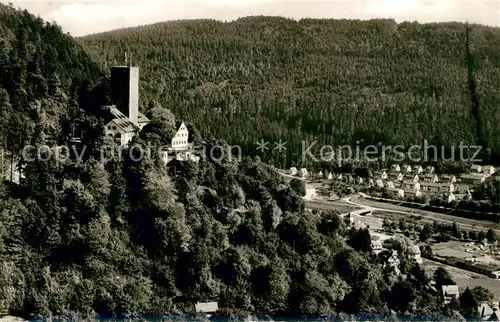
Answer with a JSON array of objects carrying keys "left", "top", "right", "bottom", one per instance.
[{"left": 111, "top": 66, "right": 139, "bottom": 124}]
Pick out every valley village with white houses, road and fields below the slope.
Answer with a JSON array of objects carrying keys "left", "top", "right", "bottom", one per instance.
[{"left": 283, "top": 164, "right": 500, "bottom": 321}]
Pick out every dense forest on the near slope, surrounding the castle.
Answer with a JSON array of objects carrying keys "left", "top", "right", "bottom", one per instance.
[{"left": 0, "top": 5, "right": 491, "bottom": 319}]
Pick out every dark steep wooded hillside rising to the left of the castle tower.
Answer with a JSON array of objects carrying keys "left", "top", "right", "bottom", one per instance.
[{"left": 0, "top": 4, "right": 103, "bottom": 157}]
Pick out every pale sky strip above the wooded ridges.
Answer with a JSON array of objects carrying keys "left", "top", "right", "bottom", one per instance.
[{"left": 0, "top": 0, "right": 500, "bottom": 37}]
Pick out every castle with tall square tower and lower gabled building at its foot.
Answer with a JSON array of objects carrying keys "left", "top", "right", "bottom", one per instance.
[{"left": 103, "top": 66, "right": 149, "bottom": 146}]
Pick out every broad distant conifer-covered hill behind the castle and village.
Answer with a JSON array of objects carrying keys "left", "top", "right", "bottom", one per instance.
[{"left": 81, "top": 17, "right": 500, "bottom": 167}]
